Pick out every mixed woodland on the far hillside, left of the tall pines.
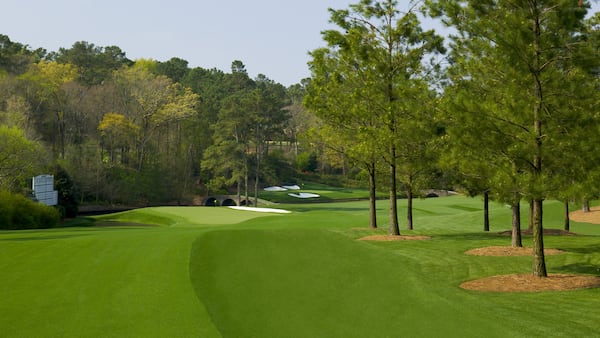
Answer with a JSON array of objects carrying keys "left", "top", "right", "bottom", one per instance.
[{"left": 0, "top": 35, "right": 324, "bottom": 209}]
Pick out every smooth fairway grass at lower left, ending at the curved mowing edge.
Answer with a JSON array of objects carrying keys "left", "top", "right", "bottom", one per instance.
[{"left": 0, "top": 228, "right": 218, "bottom": 337}]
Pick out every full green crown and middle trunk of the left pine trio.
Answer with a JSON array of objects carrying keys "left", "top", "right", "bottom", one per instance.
[{"left": 305, "top": 1, "right": 445, "bottom": 234}]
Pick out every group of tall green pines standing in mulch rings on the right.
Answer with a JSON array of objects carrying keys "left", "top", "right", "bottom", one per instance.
[{"left": 305, "top": 0, "right": 600, "bottom": 276}]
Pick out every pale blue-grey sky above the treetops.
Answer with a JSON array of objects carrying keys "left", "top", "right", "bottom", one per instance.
[{"left": 0, "top": 0, "right": 600, "bottom": 86}]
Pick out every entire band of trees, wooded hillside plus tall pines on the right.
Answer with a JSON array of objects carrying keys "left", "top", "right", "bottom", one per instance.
[{"left": 0, "top": 0, "right": 600, "bottom": 269}]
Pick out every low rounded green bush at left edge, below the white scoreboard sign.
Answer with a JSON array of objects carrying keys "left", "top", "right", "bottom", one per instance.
[{"left": 0, "top": 191, "right": 60, "bottom": 230}]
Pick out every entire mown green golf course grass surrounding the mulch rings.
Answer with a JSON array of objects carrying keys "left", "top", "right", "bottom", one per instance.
[{"left": 0, "top": 197, "right": 600, "bottom": 337}]
